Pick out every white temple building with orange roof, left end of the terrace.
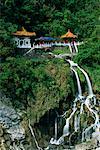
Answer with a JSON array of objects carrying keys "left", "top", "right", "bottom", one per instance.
[{"left": 12, "top": 27, "right": 36, "bottom": 48}]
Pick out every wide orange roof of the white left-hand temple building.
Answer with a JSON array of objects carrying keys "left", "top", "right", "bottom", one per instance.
[{"left": 12, "top": 27, "right": 36, "bottom": 36}]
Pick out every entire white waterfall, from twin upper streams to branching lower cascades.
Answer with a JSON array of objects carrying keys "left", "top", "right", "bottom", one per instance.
[{"left": 46, "top": 60, "right": 100, "bottom": 149}]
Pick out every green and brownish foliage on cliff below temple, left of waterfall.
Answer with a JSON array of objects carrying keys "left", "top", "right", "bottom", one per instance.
[{"left": 0, "top": 58, "right": 70, "bottom": 122}]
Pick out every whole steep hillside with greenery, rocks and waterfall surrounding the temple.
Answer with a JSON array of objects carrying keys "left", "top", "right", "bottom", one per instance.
[{"left": 0, "top": 0, "right": 100, "bottom": 150}]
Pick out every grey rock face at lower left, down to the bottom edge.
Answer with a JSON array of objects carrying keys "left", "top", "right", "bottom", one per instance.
[{"left": 0, "top": 101, "right": 25, "bottom": 150}]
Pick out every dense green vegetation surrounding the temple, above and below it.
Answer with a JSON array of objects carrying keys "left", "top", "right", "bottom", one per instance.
[{"left": 0, "top": 0, "right": 100, "bottom": 122}]
